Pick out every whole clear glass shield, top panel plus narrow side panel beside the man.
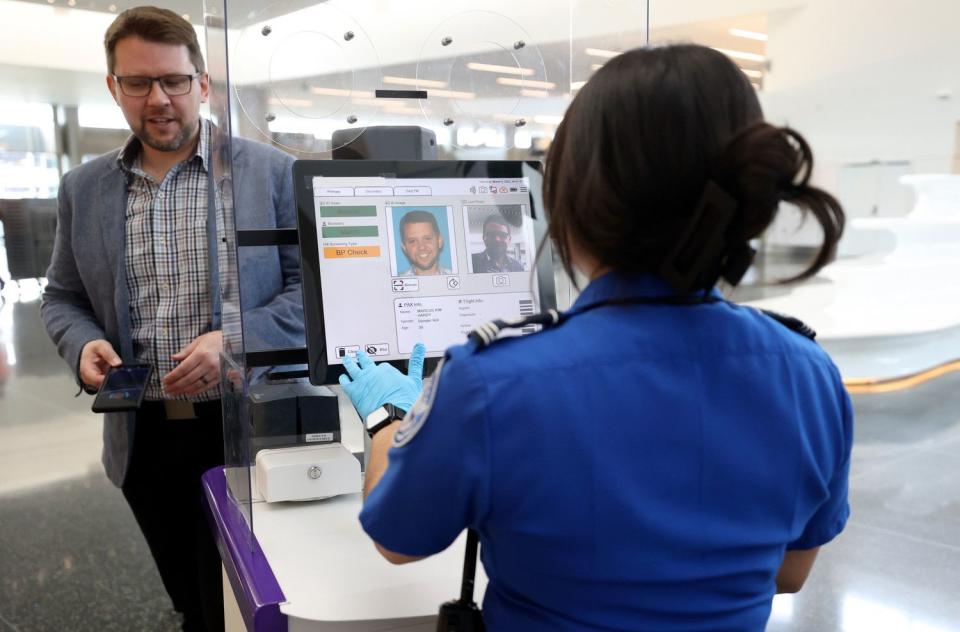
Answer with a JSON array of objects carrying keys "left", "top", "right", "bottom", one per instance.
[{"left": 205, "top": 0, "right": 647, "bottom": 540}]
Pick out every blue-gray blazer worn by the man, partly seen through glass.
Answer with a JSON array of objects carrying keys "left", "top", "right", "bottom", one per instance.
[{"left": 40, "top": 139, "right": 304, "bottom": 486}]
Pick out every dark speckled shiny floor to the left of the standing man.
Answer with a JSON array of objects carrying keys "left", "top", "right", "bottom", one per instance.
[{"left": 0, "top": 282, "right": 180, "bottom": 632}]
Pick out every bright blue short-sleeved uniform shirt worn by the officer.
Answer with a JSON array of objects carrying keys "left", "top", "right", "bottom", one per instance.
[{"left": 360, "top": 273, "right": 853, "bottom": 632}]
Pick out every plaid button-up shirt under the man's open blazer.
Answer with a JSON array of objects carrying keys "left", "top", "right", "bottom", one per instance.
[{"left": 117, "top": 119, "right": 221, "bottom": 402}]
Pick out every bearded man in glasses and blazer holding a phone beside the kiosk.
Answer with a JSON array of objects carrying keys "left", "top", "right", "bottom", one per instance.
[{"left": 41, "top": 7, "right": 303, "bottom": 630}]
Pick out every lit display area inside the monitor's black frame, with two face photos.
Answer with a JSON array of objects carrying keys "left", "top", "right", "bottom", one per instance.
[{"left": 312, "top": 177, "right": 539, "bottom": 364}]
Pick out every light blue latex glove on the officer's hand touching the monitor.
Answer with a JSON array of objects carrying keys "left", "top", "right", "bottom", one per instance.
[{"left": 340, "top": 342, "right": 427, "bottom": 419}]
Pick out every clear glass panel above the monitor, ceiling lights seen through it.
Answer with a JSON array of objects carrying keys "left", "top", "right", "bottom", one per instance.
[{"left": 217, "top": 0, "right": 646, "bottom": 157}]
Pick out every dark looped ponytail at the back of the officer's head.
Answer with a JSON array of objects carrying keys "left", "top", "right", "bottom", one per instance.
[{"left": 714, "top": 123, "right": 845, "bottom": 283}]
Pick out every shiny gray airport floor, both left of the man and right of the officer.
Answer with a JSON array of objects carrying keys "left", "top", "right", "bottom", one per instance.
[{"left": 0, "top": 284, "right": 960, "bottom": 632}]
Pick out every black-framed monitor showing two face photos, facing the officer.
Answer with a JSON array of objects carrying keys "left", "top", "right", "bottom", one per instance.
[{"left": 294, "top": 160, "right": 555, "bottom": 384}]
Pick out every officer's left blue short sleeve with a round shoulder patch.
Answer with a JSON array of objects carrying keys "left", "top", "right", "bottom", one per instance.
[{"left": 360, "top": 356, "right": 489, "bottom": 556}]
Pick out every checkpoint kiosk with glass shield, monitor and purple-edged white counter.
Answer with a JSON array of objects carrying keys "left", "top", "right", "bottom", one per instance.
[{"left": 204, "top": 0, "right": 648, "bottom": 631}]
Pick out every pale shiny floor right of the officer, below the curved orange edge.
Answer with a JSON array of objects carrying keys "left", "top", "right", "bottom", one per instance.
[{"left": 768, "top": 373, "right": 960, "bottom": 632}]
